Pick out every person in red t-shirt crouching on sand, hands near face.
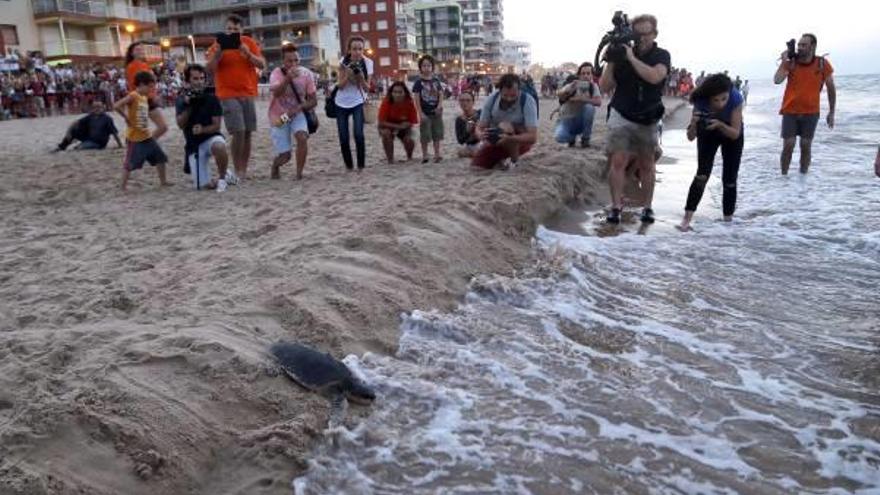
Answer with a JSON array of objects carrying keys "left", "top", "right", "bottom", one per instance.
[{"left": 378, "top": 81, "right": 419, "bottom": 163}]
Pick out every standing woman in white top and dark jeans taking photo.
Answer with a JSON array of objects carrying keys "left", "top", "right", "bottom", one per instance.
[{"left": 335, "top": 36, "right": 373, "bottom": 171}]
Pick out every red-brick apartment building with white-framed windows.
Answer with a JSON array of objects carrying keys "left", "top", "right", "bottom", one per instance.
[{"left": 337, "top": 0, "right": 417, "bottom": 79}]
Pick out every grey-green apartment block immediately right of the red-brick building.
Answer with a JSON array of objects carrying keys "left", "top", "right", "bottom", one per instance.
[{"left": 411, "top": 0, "right": 464, "bottom": 74}]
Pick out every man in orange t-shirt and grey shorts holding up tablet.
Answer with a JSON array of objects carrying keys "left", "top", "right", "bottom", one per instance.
[{"left": 207, "top": 14, "right": 266, "bottom": 184}]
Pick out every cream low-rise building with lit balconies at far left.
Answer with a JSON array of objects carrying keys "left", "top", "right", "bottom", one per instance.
[{"left": 0, "top": 0, "right": 158, "bottom": 62}]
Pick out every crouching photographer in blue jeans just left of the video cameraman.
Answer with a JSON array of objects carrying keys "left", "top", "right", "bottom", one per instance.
[{"left": 555, "top": 62, "right": 602, "bottom": 148}]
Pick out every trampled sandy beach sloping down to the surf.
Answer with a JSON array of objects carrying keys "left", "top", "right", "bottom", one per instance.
[{"left": 0, "top": 94, "right": 648, "bottom": 494}]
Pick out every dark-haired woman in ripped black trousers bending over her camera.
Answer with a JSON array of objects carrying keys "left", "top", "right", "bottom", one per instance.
[{"left": 679, "top": 74, "right": 745, "bottom": 232}]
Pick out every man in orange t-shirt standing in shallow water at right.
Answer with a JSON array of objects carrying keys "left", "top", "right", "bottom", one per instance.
[{"left": 773, "top": 33, "right": 837, "bottom": 175}]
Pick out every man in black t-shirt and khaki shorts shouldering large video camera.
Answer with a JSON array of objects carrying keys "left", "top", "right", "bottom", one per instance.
[{"left": 599, "top": 15, "right": 671, "bottom": 224}]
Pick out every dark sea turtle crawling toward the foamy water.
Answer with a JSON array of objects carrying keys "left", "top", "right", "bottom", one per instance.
[{"left": 270, "top": 342, "right": 376, "bottom": 424}]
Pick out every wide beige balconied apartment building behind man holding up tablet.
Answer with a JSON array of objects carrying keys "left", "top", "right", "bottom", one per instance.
[{"left": 147, "top": 0, "right": 340, "bottom": 74}]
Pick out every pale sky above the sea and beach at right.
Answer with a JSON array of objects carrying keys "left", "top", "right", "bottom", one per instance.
[{"left": 504, "top": 0, "right": 880, "bottom": 79}]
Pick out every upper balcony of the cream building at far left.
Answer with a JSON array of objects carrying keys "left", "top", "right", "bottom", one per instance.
[{"left": 32, "top": 0, "right": 156, "bottom": 24}]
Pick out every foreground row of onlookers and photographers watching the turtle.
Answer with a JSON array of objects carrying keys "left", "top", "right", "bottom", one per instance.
[{"left": 36, "top": 11, "right": 836, "bottom": 231}]
